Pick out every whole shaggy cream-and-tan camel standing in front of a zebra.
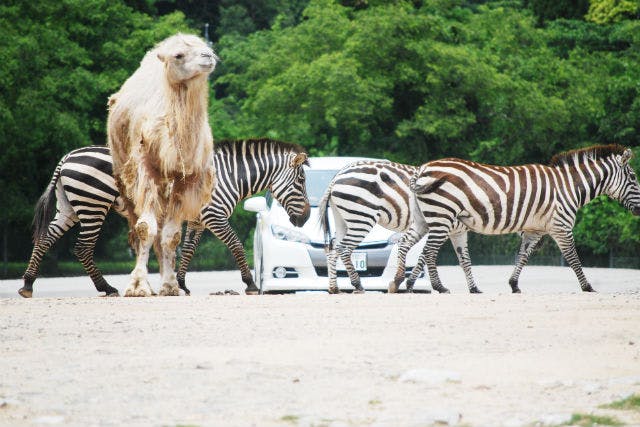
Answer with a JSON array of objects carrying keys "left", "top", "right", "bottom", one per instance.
[{"left": 107, "top": 34, "right": 218, "bottom": 296}]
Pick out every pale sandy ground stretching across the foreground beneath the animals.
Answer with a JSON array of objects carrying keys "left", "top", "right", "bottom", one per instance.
[{"left": 0, "top": 266, "right": 640, "bottom": 427}]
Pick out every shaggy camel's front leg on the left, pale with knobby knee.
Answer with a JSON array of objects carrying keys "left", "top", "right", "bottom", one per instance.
[{"left": 124, "top": 212, "right": 158, "bottom": 297}]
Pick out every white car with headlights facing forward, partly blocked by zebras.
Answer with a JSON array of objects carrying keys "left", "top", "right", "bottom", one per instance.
[{"left": 244, "top": 157, "right": 427, "bottom": 293}]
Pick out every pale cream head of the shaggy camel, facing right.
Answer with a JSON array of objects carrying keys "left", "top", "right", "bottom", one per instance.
[{"left": 155, "top": 33, "right": 219, "bottom": 84}]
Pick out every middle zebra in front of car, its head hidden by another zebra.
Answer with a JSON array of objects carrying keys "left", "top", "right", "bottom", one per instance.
[{"left": 319, "top": 160, "right": 427, "bottom": 293}]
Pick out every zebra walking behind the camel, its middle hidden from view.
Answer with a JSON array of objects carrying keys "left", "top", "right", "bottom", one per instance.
[{"left": 18, "top": 139, "right": 310, "bottom": 298}]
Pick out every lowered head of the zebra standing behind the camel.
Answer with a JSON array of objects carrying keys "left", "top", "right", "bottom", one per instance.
[{"left": 271, "top": 153, "right": 311, "bottom": 227}]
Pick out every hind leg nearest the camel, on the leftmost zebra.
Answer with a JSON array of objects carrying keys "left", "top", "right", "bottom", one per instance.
[{"left": 73, "top": 221, "right": 120, "bottom": 297}]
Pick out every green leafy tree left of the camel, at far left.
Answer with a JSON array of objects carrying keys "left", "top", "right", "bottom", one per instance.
[{"left": 0, "top": 0, "right": 188, "bottom": 268}]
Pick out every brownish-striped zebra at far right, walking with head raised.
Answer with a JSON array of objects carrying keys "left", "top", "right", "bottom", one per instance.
[{"left": 409, "top": 145, "right": 640, "bottom": 293}]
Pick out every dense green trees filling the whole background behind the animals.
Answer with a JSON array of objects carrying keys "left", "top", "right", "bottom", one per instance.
[{"left": 0, "top": 0, "right": 640, "bottom": 278}]
